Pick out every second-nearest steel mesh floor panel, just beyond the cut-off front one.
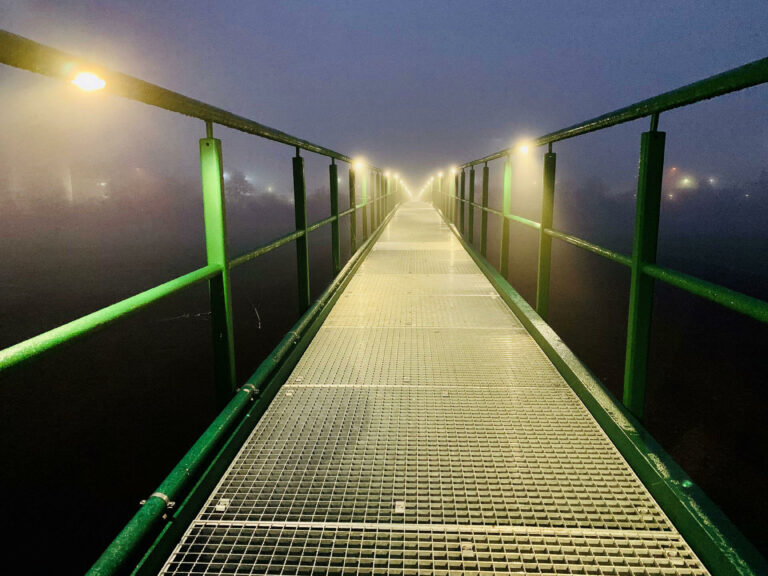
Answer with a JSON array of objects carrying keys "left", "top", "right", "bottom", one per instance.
[{"left": 196, "top": 386, "right": 670, "bottom": 530}]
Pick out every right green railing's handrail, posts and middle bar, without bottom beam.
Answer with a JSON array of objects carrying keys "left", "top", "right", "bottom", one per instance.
[{"left": 431, "top": 58, "right": 768, "bottom": 419}]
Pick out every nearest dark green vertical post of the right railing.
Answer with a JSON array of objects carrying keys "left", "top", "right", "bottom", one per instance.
[{"left": 624, "top": 115, "right": 666, "bottom": 420}]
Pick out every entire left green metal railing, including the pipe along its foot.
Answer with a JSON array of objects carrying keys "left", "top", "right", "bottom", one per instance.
[{"left": 0, "top": 30, "right": 400, "bottom": 574}]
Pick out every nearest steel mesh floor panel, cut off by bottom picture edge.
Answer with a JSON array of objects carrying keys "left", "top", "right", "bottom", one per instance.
[{"left": 164, "top": 524, "right": 706, "bottom": 576}]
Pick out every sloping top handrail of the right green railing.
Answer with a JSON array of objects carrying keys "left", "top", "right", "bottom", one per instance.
[{"left": 460, "top": 58, "right": 768, "bottom": 168}]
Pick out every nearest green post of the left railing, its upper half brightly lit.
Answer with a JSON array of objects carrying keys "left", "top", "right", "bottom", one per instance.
[{"left": 200, "top": 122, "right": 237, "bottom": 407}]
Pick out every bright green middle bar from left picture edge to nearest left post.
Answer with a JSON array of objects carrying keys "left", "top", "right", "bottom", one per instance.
[{"left": 0, "top": 265, "right": 221, "bottom": 371}]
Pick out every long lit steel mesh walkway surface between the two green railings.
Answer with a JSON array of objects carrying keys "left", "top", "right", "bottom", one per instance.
[{"left": 163, "top": 203, "right": 706, "bottom": 575}]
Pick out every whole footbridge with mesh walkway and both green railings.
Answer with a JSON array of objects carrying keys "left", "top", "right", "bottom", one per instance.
[{"left": 0, "top": 32, "right": 768, "bottom": 576}]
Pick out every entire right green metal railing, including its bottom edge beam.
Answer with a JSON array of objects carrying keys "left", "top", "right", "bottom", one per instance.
[{"left": 430, "top": 58, "right": 768, "bottom": 576}]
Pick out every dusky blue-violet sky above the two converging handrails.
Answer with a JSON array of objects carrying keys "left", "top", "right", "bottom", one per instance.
[{"left": 0, "top": 0, "right": 768, "bottom": 186}]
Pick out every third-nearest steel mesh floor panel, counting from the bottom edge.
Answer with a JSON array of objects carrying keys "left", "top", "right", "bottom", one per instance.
[{"left": 288, "top": 326, "right": 567, "bottom": 389}]
